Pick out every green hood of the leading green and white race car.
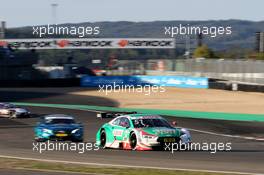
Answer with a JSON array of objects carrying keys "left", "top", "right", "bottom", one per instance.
[{"left": 142, "top": 127, "right": 181, "bottom": 137}]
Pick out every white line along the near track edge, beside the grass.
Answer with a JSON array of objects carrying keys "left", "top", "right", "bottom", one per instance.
[{"left": 0, "top": 155, "right": 264, "bottom": 175}]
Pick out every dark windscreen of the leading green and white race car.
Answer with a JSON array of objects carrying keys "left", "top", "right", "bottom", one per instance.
[{"left": 132, "top": 118, "right": 171, "bottom": 128}]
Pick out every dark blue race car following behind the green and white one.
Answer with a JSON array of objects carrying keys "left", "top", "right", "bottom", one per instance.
[{"left": 34, "top": 114, "right": 83, "bottom": 142}]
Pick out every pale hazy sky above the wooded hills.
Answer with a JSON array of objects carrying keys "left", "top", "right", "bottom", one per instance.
[{"left": 0, "top": 0, "right": 264, "bottom": 27}]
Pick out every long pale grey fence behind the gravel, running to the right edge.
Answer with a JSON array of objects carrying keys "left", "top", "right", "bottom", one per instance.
[{"left": 112, "top": 59, "right": 264, "bottom": 84}]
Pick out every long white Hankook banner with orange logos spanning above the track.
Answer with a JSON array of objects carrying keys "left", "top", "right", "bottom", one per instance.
[{"left": 0, "top": 38, "right": 175, "bottom": 49}]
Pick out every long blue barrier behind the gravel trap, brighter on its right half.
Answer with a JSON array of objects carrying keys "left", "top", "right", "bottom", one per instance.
[{"left": 81, "top": 75, "right": 208, "bottom": 88}]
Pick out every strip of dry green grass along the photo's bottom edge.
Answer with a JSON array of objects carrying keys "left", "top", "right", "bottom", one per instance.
[{"left": 0, "top": 158, "right": 243, "bottom": 175}]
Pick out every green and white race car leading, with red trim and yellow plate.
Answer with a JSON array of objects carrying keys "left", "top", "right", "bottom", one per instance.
[{"left": 96, "top": 114, "right": 191, "bottom": 150}]
